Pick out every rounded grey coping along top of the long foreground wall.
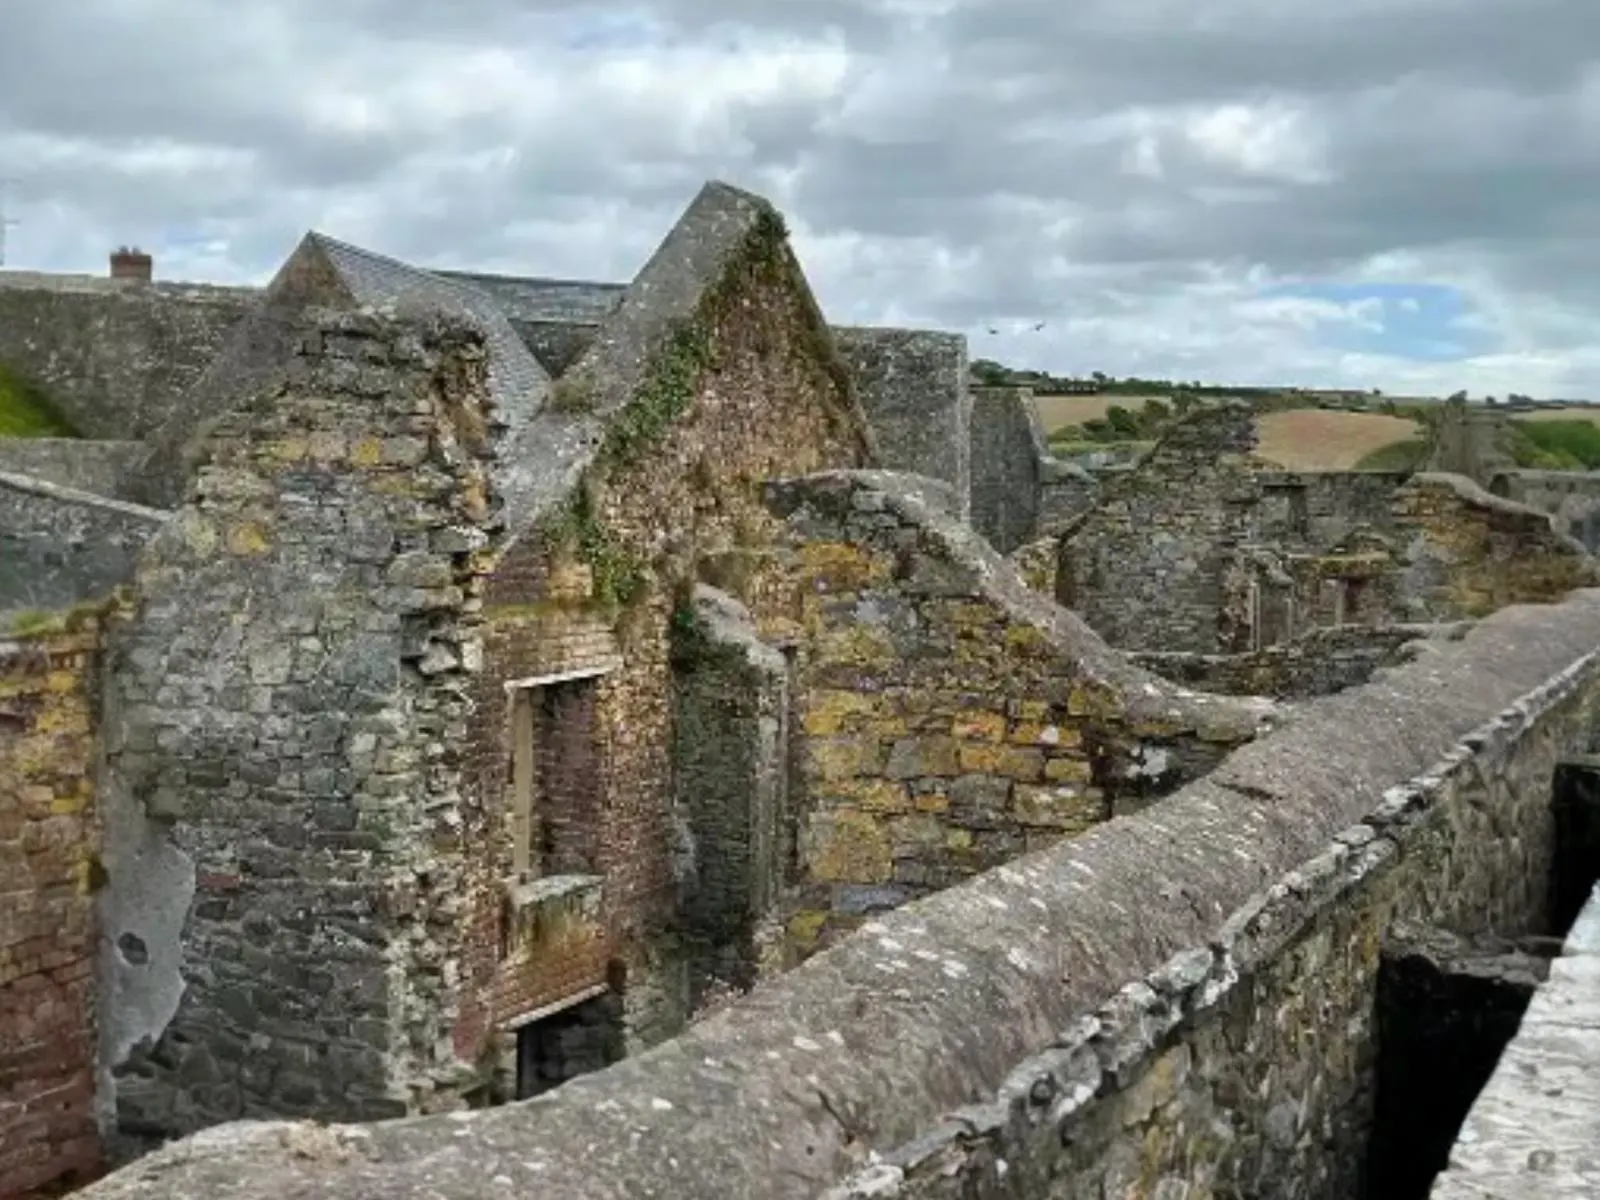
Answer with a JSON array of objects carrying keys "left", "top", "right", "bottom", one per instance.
[{"left": 80, "top": 590, "right": 1600, "bottom": 1200}]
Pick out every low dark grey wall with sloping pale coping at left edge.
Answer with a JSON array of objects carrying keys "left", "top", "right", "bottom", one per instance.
[{"left": 0, "top": 474, "right": 168, "bottom": 622}]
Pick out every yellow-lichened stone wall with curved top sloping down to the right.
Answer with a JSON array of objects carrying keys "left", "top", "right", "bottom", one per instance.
[{"left": 771, "top": 472, "right": 1264, "bottom": 954}]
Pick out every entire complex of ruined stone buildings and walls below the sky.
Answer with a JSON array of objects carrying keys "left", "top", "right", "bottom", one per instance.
[{"left": 0, "top": 184, "right": 1600, "bottom": 1200}]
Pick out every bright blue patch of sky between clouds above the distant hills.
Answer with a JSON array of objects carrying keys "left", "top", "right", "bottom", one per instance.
[{"left": 1261, "top": 283, "right": 1498, "bottom": 363}]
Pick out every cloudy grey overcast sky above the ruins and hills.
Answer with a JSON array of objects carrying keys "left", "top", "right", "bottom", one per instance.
[{"left": 0, "top": 0, "right": 1600, "bottom": 397}]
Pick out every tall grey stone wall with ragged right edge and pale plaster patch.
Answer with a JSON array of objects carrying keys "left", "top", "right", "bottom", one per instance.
[{"left": 99, "top": 312, "right": 491, "bottom": 1149}]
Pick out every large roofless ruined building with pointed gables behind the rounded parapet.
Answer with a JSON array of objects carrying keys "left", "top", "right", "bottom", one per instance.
[{"left": 0, "top": 184, "right": 1264, "bottom": 1196}]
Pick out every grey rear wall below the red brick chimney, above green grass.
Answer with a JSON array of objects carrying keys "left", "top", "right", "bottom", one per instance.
[{"left": 0, "top": 270, "right": 259, "bottom": 440}]
